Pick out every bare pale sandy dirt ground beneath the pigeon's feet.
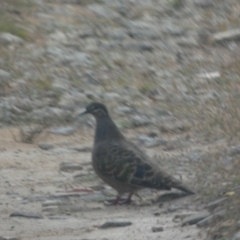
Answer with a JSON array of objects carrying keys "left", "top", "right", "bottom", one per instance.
[{"left": 0, "top": 126, "right": 204, "bottom": 240}]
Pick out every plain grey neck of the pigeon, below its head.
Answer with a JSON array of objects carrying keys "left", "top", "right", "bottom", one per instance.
[{"left": 94, "top": 116, "right": 125, "bottom": 144}]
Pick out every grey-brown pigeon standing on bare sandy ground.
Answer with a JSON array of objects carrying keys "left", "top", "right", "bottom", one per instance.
[{"left": 81, "top": 102, "right": 195, "bottom": 205}]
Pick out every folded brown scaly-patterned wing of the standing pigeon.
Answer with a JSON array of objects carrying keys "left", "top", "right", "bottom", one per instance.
[{"left": 95, "top": 142, "right": 173, "bottom": 190}]
